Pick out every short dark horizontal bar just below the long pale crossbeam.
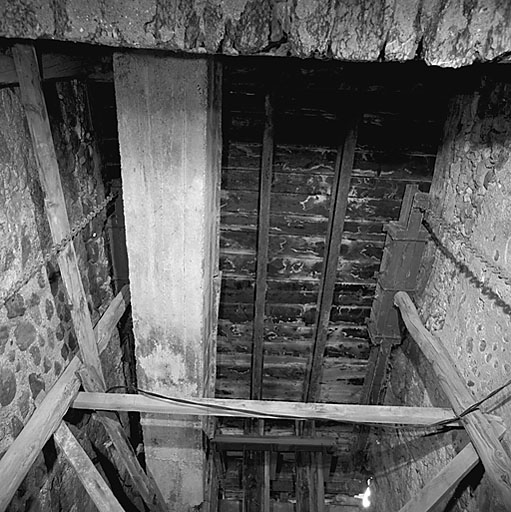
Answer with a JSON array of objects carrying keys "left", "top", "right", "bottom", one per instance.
[{"left": 212, "top": 435, "right": 337, "bottom": 452}]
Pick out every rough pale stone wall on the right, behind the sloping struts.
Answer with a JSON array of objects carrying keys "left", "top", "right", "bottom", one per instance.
[{"left": 372, "top": 70, "right": 511, "bottom": 512}]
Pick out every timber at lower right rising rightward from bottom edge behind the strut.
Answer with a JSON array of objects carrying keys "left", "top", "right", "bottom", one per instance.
[{"left": 399, "top": 420, "right": 506, "bottom": 512}]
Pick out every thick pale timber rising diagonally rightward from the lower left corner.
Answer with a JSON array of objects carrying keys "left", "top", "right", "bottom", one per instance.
[{"left": 0, "top": 286, "right": 130, "bottom": 510}]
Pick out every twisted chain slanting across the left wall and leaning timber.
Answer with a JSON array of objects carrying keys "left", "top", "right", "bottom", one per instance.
[{"left": 0, "top": 192, "right": 117, "bottom": 308}]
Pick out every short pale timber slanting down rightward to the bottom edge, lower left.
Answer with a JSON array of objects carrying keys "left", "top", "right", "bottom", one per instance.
[{"left": 54, "top": 422, "right": 124, "bottom": 512}]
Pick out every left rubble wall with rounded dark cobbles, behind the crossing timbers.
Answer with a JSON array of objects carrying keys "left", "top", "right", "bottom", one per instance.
[{"left": 0, "top": 81, "right": 123, "bottom": 510}]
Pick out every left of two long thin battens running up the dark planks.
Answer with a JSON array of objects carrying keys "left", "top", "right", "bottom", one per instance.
[{"left": 250, "top": 93, "right": 274, "bottom": 400}]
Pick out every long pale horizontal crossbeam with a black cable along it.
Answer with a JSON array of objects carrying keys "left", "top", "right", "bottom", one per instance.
[{"left": 73, "top": 393, "right": 476, "bottom": 425}]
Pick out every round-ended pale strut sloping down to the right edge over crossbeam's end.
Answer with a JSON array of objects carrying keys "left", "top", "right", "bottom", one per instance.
[{"left": 394, "top": 292, "right": 511, "bottom": 507}]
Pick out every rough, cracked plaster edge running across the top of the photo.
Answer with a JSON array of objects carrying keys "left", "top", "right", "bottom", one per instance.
[{"left": 0, "top": 0, "right": 511, "bottom": 67}]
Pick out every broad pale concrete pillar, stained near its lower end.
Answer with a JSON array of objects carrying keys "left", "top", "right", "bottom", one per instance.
[{"left": 114, "top": 53, "right": 221, "bottom": 511}]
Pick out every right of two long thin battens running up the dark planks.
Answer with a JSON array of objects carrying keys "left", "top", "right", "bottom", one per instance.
[{"left": 304, "top": 116, "right": 357, "bottom": 402}]
